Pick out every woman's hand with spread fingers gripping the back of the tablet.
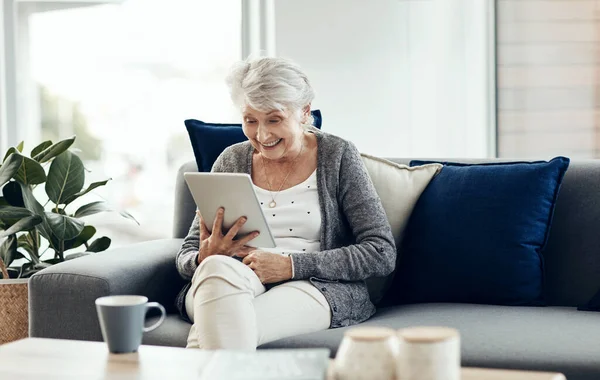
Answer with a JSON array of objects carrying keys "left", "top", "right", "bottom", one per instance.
[{"left": 196, "top": 207, "right": 259, "bottom": 264}]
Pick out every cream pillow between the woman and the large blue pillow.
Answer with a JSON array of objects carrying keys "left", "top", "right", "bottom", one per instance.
[{"left": 361, "top": 153, "right": 443, "bottom": 304}]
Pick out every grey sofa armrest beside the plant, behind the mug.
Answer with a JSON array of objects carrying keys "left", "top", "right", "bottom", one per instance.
[{"left": 29, "top": 239, "right": 185, "bottom": 341}]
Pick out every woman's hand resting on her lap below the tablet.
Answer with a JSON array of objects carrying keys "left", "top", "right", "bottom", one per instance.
[{"left": 237, "top": 250, "right": 292, "bottom": 284}]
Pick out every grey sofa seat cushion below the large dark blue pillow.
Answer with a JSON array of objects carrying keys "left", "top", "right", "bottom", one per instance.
[{"left": 261, "top": 303, "right": 600, "bottom": 380}]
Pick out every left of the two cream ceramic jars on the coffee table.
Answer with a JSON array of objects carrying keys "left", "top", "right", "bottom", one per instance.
[{"left": 333, "top": 327, "right": 398, "bottom": 380}]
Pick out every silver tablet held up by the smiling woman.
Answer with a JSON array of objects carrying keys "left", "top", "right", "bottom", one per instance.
[{"left": 183, "top": 172, "right": 276, "bottom": 248}]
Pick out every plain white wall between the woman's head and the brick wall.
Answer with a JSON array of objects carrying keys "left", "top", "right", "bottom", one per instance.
[{"left": 274, "top": 0, "right": 494, "bottom": 157}]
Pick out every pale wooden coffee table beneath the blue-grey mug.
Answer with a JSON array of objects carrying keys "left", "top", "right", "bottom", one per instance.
[{"left": 0, "top": 338, "right": 565, "bottom": 380}]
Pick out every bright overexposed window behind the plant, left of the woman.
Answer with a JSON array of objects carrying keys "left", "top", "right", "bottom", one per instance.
[{"left": 28, "top": 0, "right": 241, "bottom": 247}]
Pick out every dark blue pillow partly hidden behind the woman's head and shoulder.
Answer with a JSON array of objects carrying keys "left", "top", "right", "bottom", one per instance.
[{"left": 185, "top": 110, "right": 323, "bottom": 172}]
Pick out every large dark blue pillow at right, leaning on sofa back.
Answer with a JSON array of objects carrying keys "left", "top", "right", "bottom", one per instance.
[{"left": 391, "top": 157, "right": 570, "bottom": 305}]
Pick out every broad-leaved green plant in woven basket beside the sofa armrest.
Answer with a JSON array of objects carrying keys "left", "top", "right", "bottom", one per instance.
[{"left": 0, "top": 136, "right": 137, "bottom": 344}]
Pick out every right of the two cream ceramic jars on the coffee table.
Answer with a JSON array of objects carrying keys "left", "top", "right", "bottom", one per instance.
[{"left": 396, "top": 327, "right": 460, "bottom": 380}]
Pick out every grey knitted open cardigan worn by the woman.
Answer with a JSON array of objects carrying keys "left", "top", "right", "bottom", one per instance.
[{"left": 176, "top": 131, "right": 396, "bottom": 327}]
